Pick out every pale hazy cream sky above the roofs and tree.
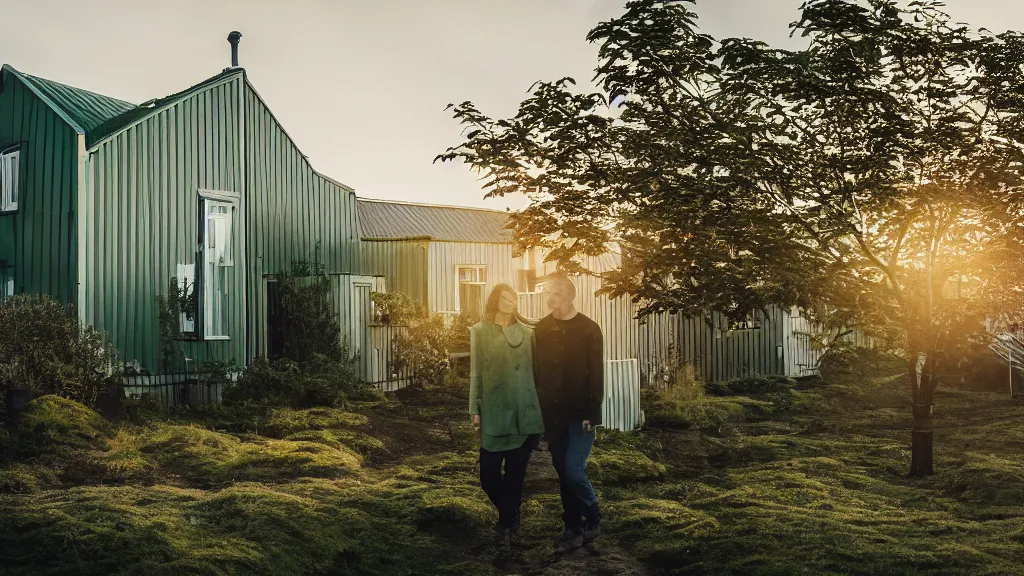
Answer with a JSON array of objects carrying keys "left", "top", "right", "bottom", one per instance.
[{"left": 0, "top": 0, "right": 1024, "bottom": 209}]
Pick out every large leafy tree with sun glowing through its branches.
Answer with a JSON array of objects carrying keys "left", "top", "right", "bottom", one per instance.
[{"left": 438, "top": 0, "right": 1024, "bottom": 476}]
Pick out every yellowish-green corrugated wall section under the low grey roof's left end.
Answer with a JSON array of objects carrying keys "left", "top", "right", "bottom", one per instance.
[{"left": 360, "top": 237, "right": 427, "bottom": 303}]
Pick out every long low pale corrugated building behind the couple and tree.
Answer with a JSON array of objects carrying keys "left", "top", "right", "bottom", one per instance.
[{"left": 357, "top": 199, "right": 856, "bottom": 426}]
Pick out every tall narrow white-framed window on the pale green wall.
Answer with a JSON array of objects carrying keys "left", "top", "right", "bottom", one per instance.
[{"left": 197, "top": 192, "right": 239, "bottom": 340}]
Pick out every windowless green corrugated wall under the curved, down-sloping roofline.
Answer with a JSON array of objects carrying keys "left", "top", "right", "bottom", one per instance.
[{"left": 245, "top": 87, "right": 362, "bottom": 355}]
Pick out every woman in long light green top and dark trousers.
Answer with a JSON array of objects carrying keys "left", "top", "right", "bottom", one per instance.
[{"left": 469, "top": 284, "right": 544, "bottom": 553}]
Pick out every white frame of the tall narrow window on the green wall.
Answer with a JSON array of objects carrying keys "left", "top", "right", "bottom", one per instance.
[{"left": 197, "top": 190, "right": 236, "bottom": 340}]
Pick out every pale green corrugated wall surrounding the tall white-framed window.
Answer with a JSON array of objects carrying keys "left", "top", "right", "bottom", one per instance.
[{"left": 80, "top": 75, "right": 244, "bottom": 371}]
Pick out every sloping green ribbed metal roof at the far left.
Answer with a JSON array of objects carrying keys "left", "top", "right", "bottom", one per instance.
[{"left": 3, "top": 65, "right": 136, "bottom": 133}]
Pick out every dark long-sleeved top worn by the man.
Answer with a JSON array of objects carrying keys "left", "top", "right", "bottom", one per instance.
[{"left": 534, "top": 314, "right": 604, "bottom": 439}]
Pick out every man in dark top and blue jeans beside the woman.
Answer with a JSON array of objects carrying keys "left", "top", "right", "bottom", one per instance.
[{"left": 534, "top": 273, "right": 604, "bottom": 551}]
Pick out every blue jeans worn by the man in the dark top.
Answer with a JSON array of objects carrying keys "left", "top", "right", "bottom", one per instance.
[{"left": 546, "top": 421, "right": 600, "bottom": 529}]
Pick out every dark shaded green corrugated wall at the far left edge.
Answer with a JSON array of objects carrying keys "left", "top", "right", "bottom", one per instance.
[{"left": 0, "top": 74, "right": 78, "bottom": 303}]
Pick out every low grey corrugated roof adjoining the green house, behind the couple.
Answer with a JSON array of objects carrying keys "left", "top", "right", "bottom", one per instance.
[{"left": 358, "top": 198, "right": 512, "bottom": 244}]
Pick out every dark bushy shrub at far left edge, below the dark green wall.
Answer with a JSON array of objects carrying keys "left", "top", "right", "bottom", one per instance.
[{"left": 0, "top": 294, "right": 120, "bottom": 406}]
